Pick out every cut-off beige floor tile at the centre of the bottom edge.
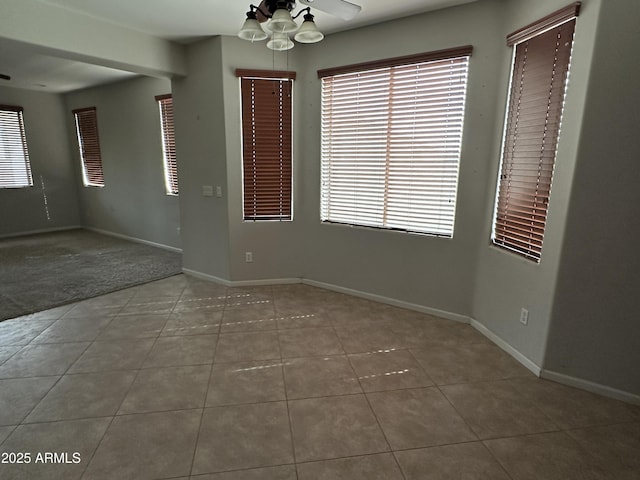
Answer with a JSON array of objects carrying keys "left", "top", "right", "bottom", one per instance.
[{"left": 298, "top": 453, "right": 404, "bottom": 480}]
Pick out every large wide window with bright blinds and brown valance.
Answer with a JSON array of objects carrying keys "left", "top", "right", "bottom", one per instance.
[{"left": 318, "top": 46, "right": 472, "bottom": 237}]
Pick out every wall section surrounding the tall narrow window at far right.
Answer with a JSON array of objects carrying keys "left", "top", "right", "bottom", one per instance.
[{"left": 473, "top": 0, "right": 600, "bottom": 367}]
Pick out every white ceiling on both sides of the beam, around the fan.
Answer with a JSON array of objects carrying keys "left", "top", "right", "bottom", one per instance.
[{"left": 0, "top": 0, "right": 477, "bottom": 92}]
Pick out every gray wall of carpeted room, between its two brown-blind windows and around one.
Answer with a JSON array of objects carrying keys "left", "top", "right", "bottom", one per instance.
[{"left": 65, "top": 77, "right": 181, "bottom": 248}]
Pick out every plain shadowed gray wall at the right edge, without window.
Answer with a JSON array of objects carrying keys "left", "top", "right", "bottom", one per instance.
[{"left": 545, "top": 0, "right": 640, "bottom": 394}]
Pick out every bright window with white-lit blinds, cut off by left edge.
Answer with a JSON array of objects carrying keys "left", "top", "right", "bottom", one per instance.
[{"left": 0, "top": 105, "right": 33, "bottom": 188}]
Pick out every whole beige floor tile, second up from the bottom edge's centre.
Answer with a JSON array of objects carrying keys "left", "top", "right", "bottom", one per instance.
[{"left": 289, "top": 395, "right": 389, "bottom": 462}]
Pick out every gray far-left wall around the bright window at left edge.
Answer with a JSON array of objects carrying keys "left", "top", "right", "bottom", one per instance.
[{"left": 0, "top": 87, "right": 80, "bottom": 236}]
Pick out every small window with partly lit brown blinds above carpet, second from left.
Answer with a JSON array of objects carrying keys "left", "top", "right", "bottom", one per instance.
[{"left": 73, "top": 107, "right": 104, "bottom": 187}]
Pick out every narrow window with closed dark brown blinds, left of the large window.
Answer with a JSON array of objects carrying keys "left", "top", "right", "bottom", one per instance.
[{"left": 236, "top": 70, "right": 295, "bottom": 221}]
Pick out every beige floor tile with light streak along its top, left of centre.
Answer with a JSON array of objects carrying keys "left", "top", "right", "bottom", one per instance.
[{"left": 206, "top": 360, "right": 286, "bottom": 407}]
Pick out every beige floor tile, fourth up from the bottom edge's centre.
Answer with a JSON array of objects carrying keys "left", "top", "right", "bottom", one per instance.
[{"left": 278, "top": 328, "right": 344, "bottom": 358}]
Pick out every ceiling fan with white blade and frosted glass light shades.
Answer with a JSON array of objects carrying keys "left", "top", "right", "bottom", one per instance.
[{"left": 238, "top": 0, "right": 362, "bottom": 50}]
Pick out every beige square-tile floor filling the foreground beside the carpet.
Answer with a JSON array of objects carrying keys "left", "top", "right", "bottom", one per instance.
[{"left": 0, "top": 275, "right": 640, "bottom": 480}]
